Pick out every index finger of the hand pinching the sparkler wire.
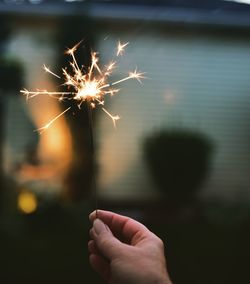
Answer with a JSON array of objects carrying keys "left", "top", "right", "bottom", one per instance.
[{"left": 89, "top": 209, "right": 151, "bottom": 243}]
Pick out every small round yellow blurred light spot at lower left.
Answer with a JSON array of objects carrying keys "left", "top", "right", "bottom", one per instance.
[{"left": 17, "top": 191, "right": 38, "bottom": 214}]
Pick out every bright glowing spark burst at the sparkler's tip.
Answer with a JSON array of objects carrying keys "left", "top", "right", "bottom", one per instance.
[{"left": 20, "top": 41, "right": 144, "bottom": 133}]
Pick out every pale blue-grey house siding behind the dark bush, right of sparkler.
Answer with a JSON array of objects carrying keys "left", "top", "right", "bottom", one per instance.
[{"left": 96, "top": 25, "right": 250, "bottom": 198}]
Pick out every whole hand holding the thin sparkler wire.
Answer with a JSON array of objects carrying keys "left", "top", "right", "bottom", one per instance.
[{"left": 88, "top": 210, "right": 171, "bottom": 284}]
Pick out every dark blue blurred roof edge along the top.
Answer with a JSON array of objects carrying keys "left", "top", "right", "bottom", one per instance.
[{"left": 0, "top": 3, "right": 250, "bottom": 28}]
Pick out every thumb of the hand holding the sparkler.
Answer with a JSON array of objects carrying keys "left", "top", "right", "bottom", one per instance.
[{"left": 93, "top": 219, "right": 122, "bottom": 260}]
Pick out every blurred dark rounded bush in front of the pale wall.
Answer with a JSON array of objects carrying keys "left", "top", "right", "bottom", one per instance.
[{"left": 144, "top": 129, "right": 213, "bottom": 202}]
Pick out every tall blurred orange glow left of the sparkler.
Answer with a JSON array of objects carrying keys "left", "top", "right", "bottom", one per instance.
[{"left": 28, "top": 81, "right": 72, "bottom": 180}]
